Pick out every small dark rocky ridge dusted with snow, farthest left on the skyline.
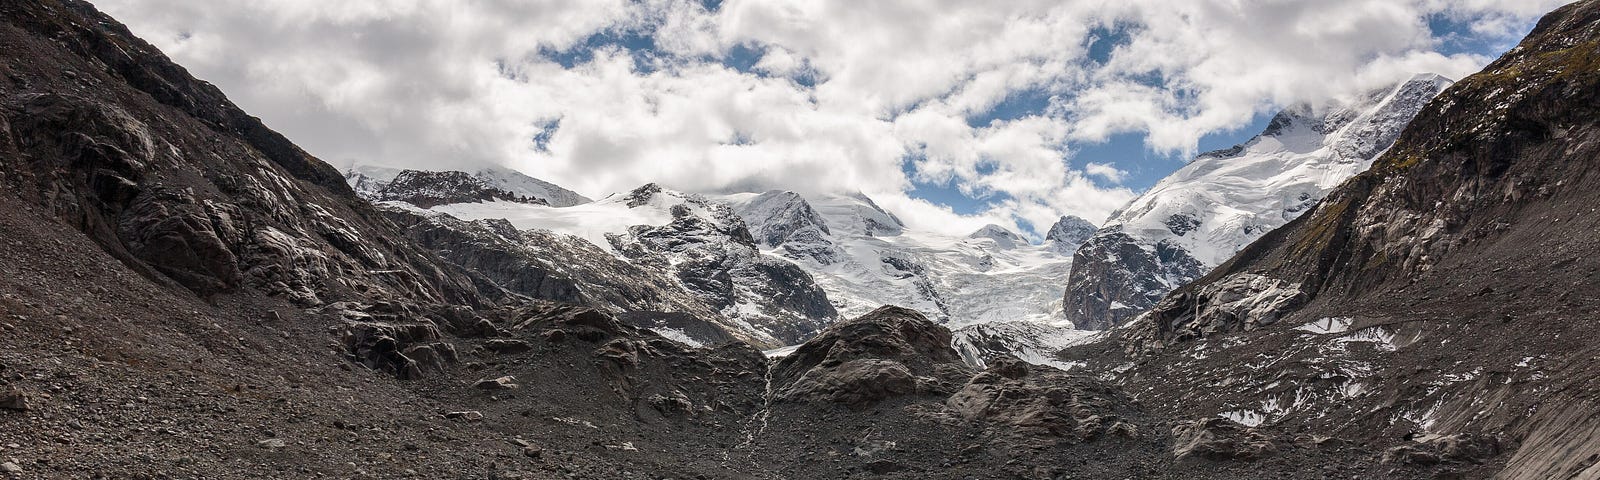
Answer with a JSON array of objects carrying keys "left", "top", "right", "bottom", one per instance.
[{"left": 344, "top": 165, "right": 592, "bottom": 208}]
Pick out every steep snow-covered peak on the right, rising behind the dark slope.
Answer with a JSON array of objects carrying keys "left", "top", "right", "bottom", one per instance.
[{"left": 1062, "top": 74, "right": 1451, "bottom": 330}]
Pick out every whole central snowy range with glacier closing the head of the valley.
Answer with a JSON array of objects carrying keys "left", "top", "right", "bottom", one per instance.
[{"left": 346, "top": 166, "right": 1093, "bottom": 348}]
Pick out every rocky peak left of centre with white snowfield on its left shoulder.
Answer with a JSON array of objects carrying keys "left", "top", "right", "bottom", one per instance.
[{"left": 393, "top": 184, "right": 838, "bottom": 346}]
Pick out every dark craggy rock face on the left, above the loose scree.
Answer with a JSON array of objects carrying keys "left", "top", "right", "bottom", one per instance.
[{"left": 0, "top": 2, "right": 482, "bottom": 306}]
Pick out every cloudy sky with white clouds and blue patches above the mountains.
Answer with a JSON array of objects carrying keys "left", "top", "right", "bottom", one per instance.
[{"left": 93, "top": 0, "right": 1565, "bottom": 234}]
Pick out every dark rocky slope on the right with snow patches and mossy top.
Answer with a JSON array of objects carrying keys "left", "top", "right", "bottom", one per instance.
[{"left": 1069, "top": 2, "right": 1600, "bottom": 478}]
